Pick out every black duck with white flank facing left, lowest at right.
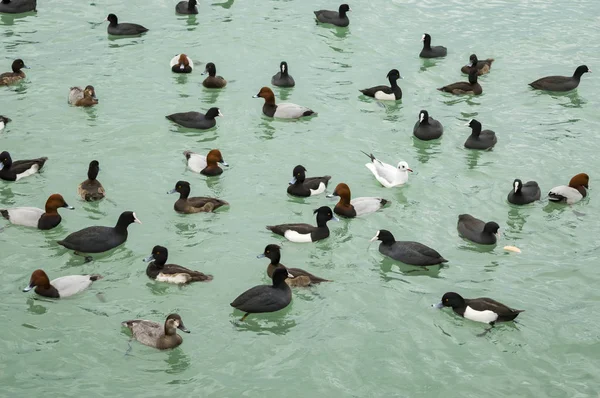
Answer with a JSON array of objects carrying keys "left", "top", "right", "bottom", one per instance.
[{"left": 435, "top": 292, "right": 524, "bottom": 326}]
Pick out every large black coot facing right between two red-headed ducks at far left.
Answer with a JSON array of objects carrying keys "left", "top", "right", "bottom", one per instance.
[{"left": 57, "top": 211, "right": 142, "bottom": 262}]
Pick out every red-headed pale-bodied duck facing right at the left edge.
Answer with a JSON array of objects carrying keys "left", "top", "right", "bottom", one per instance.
[{"left": 0, "top": 193, "right": 75, "bottom": 230}]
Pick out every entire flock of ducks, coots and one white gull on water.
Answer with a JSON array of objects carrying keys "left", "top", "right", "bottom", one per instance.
[{"left": 0, "top": 0, "right": 590, "bottom": 349}]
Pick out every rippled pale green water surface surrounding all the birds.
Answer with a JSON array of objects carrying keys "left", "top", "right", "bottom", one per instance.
[{"left": 0, "top": 0, "right": 600, "bottom": 398}]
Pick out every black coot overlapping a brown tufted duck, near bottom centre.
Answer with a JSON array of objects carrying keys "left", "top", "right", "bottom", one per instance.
[{"left": 229, "top": 268, "right": 294, "bottom": 322}]
